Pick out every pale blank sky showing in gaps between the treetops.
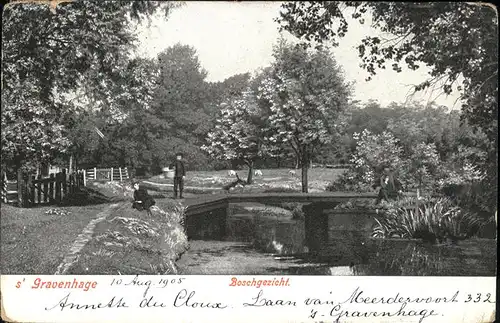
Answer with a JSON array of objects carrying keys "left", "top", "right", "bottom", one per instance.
[{"left": 137, "top": 1, "right": 460, "bottom": 109}]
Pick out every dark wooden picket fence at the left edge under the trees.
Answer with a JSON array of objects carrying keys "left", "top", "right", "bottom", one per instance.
[{"left": 2, "top": 170, "right": 85, "bottom": 207}]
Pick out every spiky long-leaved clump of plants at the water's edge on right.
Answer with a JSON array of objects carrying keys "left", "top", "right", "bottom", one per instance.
[{"left": 373, "top": 198, "right": 485, "bottom": 242}]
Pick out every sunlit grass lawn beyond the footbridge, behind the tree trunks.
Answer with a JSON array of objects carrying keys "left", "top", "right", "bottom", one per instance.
[{"left": 147, "top": 168, "right": 345, "bottom": 192}]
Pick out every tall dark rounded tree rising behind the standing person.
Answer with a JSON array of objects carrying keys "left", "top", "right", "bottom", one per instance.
[{"left": 152, "top": 44, "right": 212, "bottom": 168}]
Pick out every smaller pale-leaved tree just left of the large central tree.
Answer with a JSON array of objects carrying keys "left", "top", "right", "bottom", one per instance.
[{"left": 203, "top": 91, "right": 265, "bottom": 184}]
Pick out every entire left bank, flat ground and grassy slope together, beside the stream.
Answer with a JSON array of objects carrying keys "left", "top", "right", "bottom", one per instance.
[{"left": 1, "top": 182, "right": 188, "bottom": 274}]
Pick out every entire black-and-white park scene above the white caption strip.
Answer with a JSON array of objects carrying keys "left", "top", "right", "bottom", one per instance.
[{"left": 0, "top": 0, "right": 498, "bottom": 279}]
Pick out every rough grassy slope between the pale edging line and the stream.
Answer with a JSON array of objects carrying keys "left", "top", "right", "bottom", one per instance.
[{"left": 68, "top": 200, "right": 188, "bottom": 275}]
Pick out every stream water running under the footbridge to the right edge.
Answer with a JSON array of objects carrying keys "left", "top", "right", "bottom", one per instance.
[{"left": 177, "top": 203, "right": 496, "bottom": 276}]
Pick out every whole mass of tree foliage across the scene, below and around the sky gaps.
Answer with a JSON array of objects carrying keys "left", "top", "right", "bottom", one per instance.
[{"left": 1, "top": 1, "right": 498, "bottom": 221}]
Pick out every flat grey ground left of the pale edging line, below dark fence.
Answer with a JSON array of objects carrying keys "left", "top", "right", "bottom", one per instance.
[{"left": 0, "top": 204, "right": 109, "bottom": 275}]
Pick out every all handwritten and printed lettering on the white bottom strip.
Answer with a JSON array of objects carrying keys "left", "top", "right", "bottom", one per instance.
[{"left": 16, "top": 275, "right": 495, "bottom": 322}]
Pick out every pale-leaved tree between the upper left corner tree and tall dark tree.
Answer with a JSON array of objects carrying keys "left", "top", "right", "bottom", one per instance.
[{"left": 64, "top": 58, "right": 163, "bottom": 171}]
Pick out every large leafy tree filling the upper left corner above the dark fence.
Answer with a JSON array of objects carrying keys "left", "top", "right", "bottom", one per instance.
[{"left": 2, "top": 1, "right": 176, "bottom": 173}]
